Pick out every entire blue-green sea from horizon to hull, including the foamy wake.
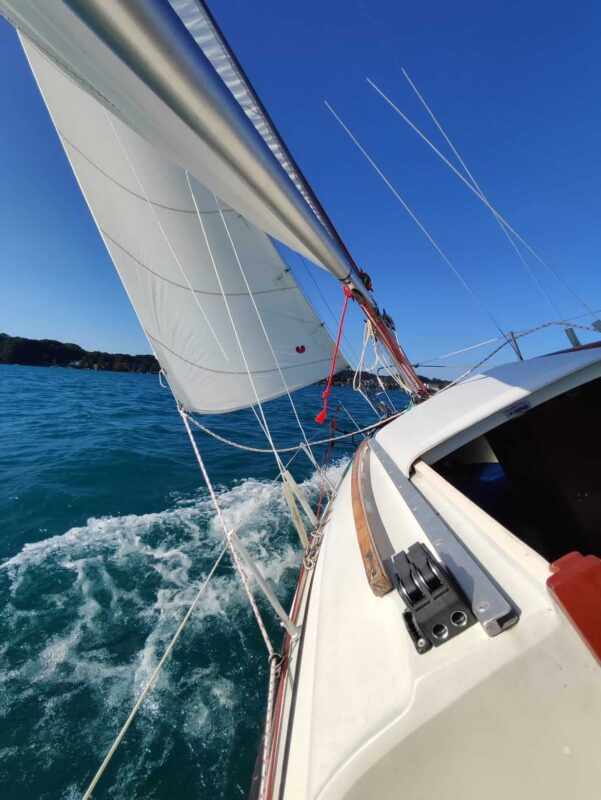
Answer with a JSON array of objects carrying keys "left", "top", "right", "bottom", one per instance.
[{"left": 0, "top": 366, "right": 403, "bottom": 800}]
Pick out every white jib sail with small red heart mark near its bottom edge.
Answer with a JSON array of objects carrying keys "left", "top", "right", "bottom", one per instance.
[{"left": 23, "top": 39, "right": 344, "bottom": 413}]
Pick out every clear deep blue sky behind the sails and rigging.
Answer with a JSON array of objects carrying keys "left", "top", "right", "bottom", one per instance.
[{"left": 0, "top": 0, "right": 601, "bottom": 374}]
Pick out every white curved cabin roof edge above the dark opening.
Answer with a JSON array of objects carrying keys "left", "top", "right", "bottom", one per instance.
[{"left": 376, "top": 348, "right": 601, "bottom": 476}]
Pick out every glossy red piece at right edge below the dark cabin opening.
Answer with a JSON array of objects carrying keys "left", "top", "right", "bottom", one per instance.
[{"left": 547, "top": 552, "right": 601, "bottom": 664}]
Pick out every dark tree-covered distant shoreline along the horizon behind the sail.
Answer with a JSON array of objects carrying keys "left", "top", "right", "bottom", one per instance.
[{"left": 0, "top": 333, "right": 448, "bottom": 391}]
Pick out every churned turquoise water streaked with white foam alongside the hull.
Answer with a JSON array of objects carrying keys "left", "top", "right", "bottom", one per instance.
[{"left": 0, "top": 461, "right": 346, "bottom": 798}]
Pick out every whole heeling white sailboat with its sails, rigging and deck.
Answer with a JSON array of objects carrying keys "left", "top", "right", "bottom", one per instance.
[{"left": 0, "top": 0, "right": 601, "bottom": 800}]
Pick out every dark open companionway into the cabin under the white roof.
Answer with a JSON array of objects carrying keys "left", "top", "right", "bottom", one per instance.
[{"left": 433, "top": 379, "right": 601, "bottom": 561}]
